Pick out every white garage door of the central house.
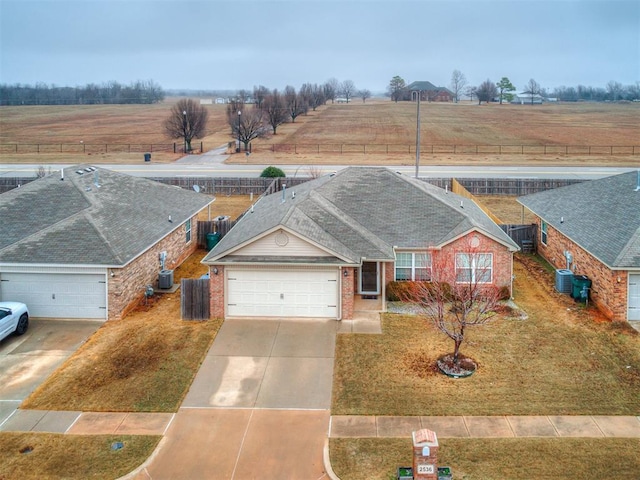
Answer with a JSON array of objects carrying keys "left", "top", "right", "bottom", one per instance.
[{"left": 227, "top": 269, "right": 338, "bottom": 318}]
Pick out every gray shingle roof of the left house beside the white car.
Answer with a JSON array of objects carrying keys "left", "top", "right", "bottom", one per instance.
[{"left": 0, "top": 165, "right": 212, "bottom": 266}]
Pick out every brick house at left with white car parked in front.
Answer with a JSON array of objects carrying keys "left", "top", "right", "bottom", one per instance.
[{"left": 0, "top": 165, "right": 213, "bottom": 320}]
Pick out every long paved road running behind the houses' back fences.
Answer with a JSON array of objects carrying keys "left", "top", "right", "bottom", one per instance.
[{"left": 0, "top": 161, "right": 640, "bottom": 180}]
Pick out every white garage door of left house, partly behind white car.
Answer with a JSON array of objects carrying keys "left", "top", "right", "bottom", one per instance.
[{"left": 0, "top": 273, "right": 107, "bottom": 318}]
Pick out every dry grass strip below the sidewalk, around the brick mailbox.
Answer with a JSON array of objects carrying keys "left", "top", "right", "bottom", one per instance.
[{"left": 329, "top": 438, "right": 640, "bottom": 480}]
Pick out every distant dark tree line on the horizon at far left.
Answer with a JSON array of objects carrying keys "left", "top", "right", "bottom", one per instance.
[{"left": 0, "top": 80, "right": 165, "bottom": 105}]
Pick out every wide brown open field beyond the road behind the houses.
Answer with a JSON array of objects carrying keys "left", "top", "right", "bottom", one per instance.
[{"left": 0, "top": 99, "right": 640, "bottom": 166}]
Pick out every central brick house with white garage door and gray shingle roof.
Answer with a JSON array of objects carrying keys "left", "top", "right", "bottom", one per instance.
[{"left": 203, "top": 167, "right": 518, "bottom": 319}]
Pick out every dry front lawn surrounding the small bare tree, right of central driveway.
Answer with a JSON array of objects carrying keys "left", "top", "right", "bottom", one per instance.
[{"left": 331, "top": 257, "right": 640, "bottom": 415}]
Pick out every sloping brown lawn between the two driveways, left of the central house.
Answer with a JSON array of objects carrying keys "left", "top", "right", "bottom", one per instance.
[{"left": 21, "top": 250, "right": 222, "bottom": 412}]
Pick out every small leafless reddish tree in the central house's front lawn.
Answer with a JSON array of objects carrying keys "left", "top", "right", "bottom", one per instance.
[{"left": 404, "top": 240, "right": 500, "bottom": 371}]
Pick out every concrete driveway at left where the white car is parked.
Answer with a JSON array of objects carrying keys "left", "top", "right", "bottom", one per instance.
[{"left": 0, "top": 318, "right": 102, "bottom": 425}]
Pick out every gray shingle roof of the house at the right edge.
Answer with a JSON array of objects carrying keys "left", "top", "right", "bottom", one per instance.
[{"left": 518, "top": 171, "right": 640, "bottom": 268}]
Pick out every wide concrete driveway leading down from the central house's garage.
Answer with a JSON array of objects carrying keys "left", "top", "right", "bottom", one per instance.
[{"left": 136, "top": 320, "right": 339, "bottom": 480}]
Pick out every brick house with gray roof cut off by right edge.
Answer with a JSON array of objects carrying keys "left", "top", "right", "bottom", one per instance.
[{"left": 518, "top": 172, "right": 640, "bottom": 321}]
